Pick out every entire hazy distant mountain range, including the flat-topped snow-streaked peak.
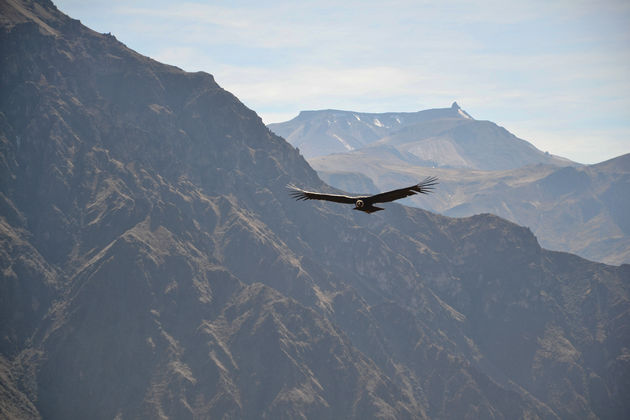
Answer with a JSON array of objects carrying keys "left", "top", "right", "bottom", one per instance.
[{"left": 268, "top": 92, "right": 630, "bottom": 264}]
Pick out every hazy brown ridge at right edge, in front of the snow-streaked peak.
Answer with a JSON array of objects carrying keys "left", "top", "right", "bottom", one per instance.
[{"left": 443, "top": 154, "right": 630, "bottom": 264}]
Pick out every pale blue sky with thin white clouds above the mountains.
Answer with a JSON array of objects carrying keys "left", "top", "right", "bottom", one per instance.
[{"left": 55, "top": 0, "right": 630, "bottom": 163}]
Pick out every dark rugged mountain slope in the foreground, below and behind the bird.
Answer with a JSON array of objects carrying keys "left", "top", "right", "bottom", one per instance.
[{"left": 0, "top": 0, "right": 630, "bottom": 419}]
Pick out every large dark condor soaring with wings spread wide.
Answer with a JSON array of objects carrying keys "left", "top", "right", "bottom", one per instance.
[{"left": 287, "top": 176, "right": 438, "bottom": 214}]
